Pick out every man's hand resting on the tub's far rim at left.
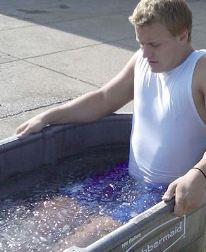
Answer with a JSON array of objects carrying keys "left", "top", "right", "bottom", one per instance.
[{"left": 16, "top": 116, "right": 45, "bottom": 137}]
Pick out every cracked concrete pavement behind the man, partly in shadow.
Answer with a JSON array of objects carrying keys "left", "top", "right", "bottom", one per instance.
[{"left": 0, "top": 0, "right": 206, "bottom": 139}]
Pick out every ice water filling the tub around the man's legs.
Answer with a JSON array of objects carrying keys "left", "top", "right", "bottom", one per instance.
[{"left": 0, "top": 149, "right": 164, "bottom": 252}]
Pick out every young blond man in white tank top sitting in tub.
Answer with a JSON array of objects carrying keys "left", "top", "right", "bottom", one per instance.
[{"left": 16, "top": 0, "right": 206, "bottom": 215}]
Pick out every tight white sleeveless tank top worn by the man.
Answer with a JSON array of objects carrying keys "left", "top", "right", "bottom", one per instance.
[{"left": 129, "top": 50, "right": 206, "bottom": 183}]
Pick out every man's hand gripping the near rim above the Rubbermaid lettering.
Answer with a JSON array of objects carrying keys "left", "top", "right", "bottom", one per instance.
[{"left": 162, "top": 169, "right": 206, "bottom": 216}]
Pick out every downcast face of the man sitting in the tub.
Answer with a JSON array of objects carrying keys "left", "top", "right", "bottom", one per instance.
[{"left": 135, "top": 23, "right": 184, "bottom": 73}]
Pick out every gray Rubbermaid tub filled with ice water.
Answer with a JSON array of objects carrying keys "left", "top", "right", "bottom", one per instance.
[{"left": 0, "top": 114, "right": 206, "bottom": 252}]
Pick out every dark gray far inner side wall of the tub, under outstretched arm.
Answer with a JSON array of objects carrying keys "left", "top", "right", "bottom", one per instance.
[{"left": 0, "top": 114, "right": 132, "bottom": 183}]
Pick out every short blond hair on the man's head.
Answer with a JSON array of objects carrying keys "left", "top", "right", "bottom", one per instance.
[{"left": 129, "top": 0, "right": 192, "bottom": 42}]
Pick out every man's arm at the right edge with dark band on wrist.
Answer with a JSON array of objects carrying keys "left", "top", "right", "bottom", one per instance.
[{"left": 162, "top": 57, "right": 206, "bottom": 216}]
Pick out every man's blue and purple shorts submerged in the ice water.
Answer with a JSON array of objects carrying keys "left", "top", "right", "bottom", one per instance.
[{"left": 61, "top": 162, "right": 167, "bottom": 223}]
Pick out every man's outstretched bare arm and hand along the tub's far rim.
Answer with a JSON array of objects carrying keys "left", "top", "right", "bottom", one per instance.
[{"left": 16, "top": 52, "right": 138, "bottom": 137}]
